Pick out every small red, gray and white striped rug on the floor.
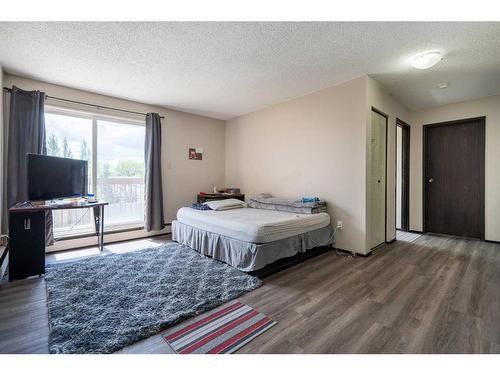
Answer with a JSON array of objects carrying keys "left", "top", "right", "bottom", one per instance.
[{"left": 163, "top": 302, "right": 277, "bottom": 354}]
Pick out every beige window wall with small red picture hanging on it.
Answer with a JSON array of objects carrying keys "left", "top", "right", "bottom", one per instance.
[{"left": 3, "top": 75, "right": 225, "bottom": 248}]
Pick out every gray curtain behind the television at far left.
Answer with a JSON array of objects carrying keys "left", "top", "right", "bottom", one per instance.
[{"left": 7, "top": 86, "right": 53, "bottom": 244}]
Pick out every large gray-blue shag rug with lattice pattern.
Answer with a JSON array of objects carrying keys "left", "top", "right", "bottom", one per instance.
[{"left": 45, "top": 243, "right": 262, "bottom": 353}]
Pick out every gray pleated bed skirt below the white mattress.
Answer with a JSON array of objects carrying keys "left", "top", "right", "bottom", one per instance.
[{"left": 172, "top": 220, "right": 333, "bottom": 272}]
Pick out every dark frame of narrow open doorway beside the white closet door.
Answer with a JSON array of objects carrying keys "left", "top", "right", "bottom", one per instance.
[{"left": 394, "top": 118, "right": 411, "bottom": 232}]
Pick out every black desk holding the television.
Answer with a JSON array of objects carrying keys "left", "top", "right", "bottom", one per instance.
[{"left": 9, "top": 201, "right": 108, "bottom": 280}]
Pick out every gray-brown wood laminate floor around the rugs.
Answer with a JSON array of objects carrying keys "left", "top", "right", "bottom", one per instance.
[{"left": 0, "top": 235, "right": 500, "bottom": 353}]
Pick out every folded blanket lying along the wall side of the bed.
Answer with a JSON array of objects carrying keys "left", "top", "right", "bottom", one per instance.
[{"left": 249, "top": 197, "right": 326, "bottom": 214}]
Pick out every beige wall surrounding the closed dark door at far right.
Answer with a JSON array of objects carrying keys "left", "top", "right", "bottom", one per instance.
[{"left": 410, "top": 96, "right": 500, "bottom": 241}]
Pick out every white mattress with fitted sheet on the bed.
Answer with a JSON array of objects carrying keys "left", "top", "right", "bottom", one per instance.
[{"left": 177, "top": 207, "right": 330, "bottom": 243}]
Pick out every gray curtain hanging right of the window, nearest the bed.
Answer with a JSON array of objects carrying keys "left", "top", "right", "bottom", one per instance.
[{"left": 144, "top": 113, "right": 165, "bottom": 232}]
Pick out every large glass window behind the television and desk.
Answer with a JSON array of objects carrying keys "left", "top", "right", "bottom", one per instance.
[{"left": 45, "top": 107, "right": 145, "bottom": 238}]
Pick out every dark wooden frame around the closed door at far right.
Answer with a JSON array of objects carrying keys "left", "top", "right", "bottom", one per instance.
[{"left": 422, "top": 116, "right": 486, "bottom": 241}]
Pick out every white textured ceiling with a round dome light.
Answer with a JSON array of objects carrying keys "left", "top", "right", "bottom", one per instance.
[{"left": 0, "top": 22, "right": 500, "bottom": 119}]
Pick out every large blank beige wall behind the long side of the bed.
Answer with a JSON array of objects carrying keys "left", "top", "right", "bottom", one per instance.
[{"left": 226, "top": 77, "right": 366, "bottom": 253}]
